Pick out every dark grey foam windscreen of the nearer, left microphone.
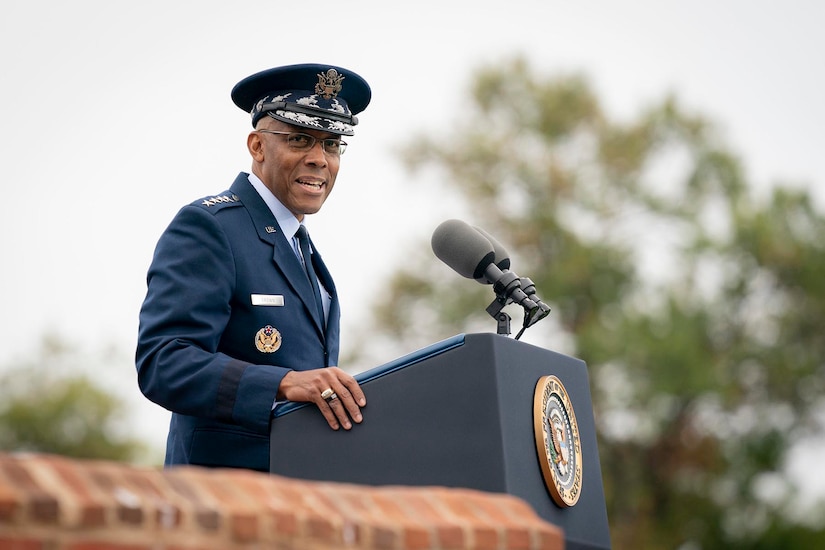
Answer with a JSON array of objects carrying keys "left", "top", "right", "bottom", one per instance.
[{"left": 431, "top": 220, "right": 495, "bottom": 279}]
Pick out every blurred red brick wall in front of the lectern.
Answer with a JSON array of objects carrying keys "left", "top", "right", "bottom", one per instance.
[{"left": 0, "top": 453, "right": 564, "bottom": 550}]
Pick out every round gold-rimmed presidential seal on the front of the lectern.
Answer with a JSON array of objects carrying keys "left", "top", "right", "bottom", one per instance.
[{"left": 533, "top": 376, "right": 582, "bottom": 508}]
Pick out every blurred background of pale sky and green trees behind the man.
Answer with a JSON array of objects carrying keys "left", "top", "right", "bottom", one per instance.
[{"left": 0, "top": 0, "right": 825, "bottom": 549}]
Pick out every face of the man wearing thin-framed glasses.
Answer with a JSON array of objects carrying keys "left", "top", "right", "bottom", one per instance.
[{"left": 247, "top": 117, "right": 341, "bottom": 220}]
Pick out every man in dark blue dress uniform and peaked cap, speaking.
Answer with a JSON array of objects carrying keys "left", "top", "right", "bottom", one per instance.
[{"left": 136, "top": 64, "right": 371, "bottom": 471}]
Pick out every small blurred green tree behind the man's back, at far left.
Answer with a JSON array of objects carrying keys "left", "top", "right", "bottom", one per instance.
[{"left": 0, "top": 338, "right": 149, "bottom": 462}]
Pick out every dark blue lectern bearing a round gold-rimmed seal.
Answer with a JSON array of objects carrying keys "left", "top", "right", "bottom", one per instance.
[{"left": 270, "top": 334, "right": 610, "bottom": 550}]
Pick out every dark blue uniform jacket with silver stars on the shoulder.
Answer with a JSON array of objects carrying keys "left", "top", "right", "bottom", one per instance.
[{"left": 136, "top": 173, "right": 340, "bottom": 471}]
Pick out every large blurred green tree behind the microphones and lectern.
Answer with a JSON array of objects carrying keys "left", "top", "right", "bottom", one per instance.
[{"left": 360, "top": 58, "right": 825, "bottom": 549}]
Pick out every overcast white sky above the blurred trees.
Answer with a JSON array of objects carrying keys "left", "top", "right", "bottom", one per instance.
[{"left": 0, "top": 0, "right": 825, "bottom": 492}]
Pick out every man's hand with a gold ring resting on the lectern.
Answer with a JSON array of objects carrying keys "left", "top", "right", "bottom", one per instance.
[{"left": 278, "top": 367, "right": 367, "bottom": 430}]
